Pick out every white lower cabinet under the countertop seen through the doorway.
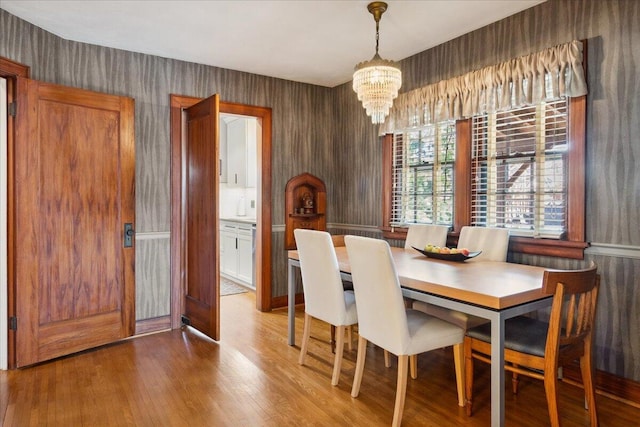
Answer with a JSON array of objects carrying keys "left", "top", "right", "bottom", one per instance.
[{"left": 220, "top": 220, "right": 255, "bottom": 288}]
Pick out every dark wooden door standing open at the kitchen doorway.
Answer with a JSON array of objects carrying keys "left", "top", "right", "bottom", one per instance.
[{"left": 182, "top": 95, "right": 220, "bottom": 340}]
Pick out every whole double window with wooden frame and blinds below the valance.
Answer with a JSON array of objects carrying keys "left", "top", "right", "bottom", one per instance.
[{"left": 382, "top": 96, "right": 587, "bottom": 259}]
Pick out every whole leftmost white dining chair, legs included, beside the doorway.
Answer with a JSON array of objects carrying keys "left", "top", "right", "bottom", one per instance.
[{"left": 293, "top": 229, "right": 358, "bottom": 386}]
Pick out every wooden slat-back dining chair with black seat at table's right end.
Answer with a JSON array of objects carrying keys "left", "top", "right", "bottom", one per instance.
[{"left": 464, "top": 263, "right": 600, "bottom": 427}]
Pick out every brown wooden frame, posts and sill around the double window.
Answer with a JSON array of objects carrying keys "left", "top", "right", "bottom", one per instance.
[{"left": 380, "top": 95, "right": 589, "bottom": 259}]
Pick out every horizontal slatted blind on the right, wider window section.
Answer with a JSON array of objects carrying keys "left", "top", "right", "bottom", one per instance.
[{"left": 471, "top": 99, "right": 568, "bottom": 238}]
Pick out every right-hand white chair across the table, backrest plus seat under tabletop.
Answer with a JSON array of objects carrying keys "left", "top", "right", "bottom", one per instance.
[{"left": 413, "top": 226, "right": 509, "bottom": 330}]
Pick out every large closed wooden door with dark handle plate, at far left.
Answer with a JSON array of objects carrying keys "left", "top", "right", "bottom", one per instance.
[{"left": 12, "top": 78, "right": 135, "bottom": 367}]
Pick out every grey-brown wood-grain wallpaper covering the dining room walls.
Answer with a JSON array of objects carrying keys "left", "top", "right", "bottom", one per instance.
[{"left": 0, "top": 0, "right": 640, "bottom": 381}]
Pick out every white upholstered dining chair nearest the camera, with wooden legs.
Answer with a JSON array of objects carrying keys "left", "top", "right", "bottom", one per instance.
[{"left": 345, "top": 236, "right": 464, "bottom": 426}]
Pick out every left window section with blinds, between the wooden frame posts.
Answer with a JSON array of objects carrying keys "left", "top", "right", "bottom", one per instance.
[{"left": 390, "top": 121, "right": 455, "bottom": 226}]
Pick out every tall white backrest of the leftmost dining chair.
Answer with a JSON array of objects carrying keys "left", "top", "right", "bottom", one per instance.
[{"left": 293, "top": 229, "right": 355, "bottom": 325}]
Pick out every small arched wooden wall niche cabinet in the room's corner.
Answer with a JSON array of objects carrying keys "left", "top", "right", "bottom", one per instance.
[{"left": 284, "top": 173, "right": 327, "bottom": 249}]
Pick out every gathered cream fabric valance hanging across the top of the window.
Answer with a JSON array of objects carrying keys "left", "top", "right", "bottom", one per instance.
[{"left": 380, "top": 40, "right": 587, "bottom": 134}]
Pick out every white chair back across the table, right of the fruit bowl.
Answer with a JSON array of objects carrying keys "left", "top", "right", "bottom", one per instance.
[{"left": 458, "top": 226, "right": 509, "bottom": 262}]
